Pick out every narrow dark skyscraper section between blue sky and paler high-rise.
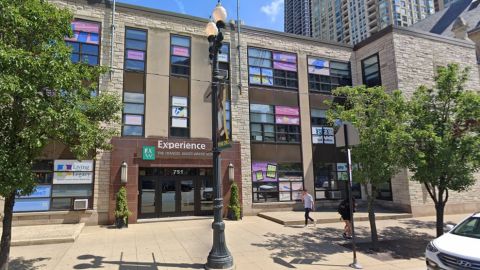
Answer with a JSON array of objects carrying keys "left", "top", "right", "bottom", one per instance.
[{"left": 284, "top": 0, "right": 312, "bottom": 36}]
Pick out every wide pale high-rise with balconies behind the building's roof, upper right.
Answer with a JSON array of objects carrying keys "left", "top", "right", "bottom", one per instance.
[{"left": 311, "top": 0, "right": 436, "bottom": 44}]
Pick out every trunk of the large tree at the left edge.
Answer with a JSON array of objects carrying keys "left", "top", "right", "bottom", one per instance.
[{"left": 0, "top": 192, "right": 15, "bottom": 270}]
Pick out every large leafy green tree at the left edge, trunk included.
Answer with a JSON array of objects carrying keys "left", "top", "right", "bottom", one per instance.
[{"left": 0, "top": 0, "right": 121, "bottom": 270}]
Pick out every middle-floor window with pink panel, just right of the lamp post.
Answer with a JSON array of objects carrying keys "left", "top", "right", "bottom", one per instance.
[{"left": 250, "top": 104, "right": 300, "bottom": 143}]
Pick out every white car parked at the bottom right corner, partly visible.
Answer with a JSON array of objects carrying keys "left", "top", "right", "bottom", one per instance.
[{"left": 425, "top": 213, "right": 480, "bottom": 270}]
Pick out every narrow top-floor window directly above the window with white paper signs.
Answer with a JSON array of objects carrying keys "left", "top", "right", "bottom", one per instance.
[{"left": 170, "top": 35, "right": 190, "bottom": 76}]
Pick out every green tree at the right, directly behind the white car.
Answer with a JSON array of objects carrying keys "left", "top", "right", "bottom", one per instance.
[{"left": 405, "top": 64, "right": 480, "bottom": 236}]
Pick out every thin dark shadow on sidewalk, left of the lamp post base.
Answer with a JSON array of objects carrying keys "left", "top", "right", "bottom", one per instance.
[{"left": 73, "top": 252, "right": 204, "bottom": 270}]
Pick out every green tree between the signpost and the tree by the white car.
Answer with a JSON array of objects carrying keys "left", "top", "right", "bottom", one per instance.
[{"left": 327, "top": 86, "right": 407, "bottom": 250}]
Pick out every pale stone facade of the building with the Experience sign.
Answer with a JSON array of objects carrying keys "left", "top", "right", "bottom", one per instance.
[{"left": 5, "top": 0, "right": 480, "bottom": 224}]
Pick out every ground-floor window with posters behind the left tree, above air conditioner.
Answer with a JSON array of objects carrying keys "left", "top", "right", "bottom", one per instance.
[{"left": 13, "top": 160, "right": 93, "bottom": 213}]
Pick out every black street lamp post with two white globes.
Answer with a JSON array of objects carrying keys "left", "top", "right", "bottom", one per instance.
[{"left": 205, "top": 0, "right": 234, "bottom": 269}]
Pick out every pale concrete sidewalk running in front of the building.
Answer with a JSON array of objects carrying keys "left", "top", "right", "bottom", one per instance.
[{"left": 11, "top": 215, "right": 465, "bottom": 270}]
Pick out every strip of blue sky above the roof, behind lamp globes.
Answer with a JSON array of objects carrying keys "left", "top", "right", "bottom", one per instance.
[{"left": 118, "top": 0, "right": 284, "bottom": 31}]
